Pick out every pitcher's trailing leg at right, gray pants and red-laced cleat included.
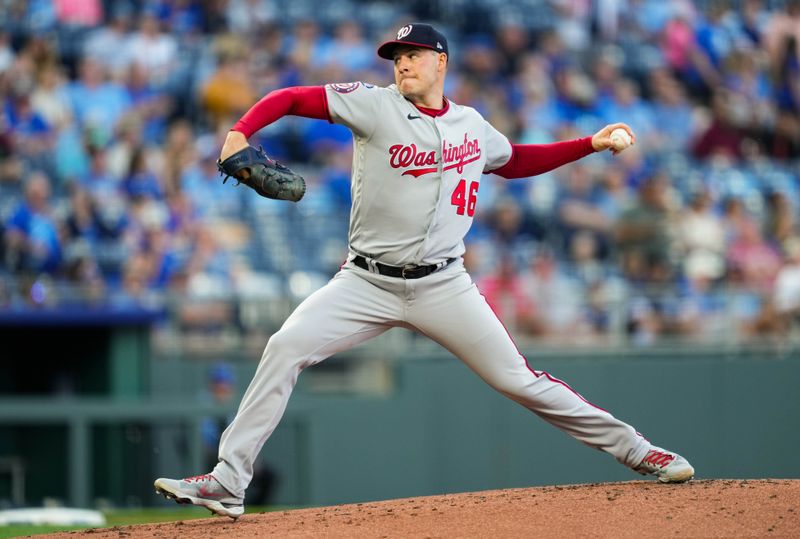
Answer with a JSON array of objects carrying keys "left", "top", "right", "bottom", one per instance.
[{"left": 407, "top": 267, "right": 694, "bottom": 481}]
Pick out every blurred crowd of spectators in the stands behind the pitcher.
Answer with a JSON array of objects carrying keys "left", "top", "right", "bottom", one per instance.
[{"left": 0, "top": 0, "right": 800, "bottom": 345}]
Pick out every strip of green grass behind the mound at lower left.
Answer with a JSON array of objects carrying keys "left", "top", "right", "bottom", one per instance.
[{"left": 0, "top": 507, "right": 286, "bottom": 539}]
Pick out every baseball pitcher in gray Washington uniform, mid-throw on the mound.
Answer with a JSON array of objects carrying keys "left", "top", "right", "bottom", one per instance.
[{"left": 155, "top": 23, "right": 694, "bottom": 519}]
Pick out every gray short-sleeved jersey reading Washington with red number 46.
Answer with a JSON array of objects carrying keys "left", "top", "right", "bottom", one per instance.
[{"left": 326, "top": 82, "right": 511, "bottom": 266}]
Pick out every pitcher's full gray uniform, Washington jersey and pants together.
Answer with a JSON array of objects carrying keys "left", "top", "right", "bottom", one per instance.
[{"left": 213, "top": 83, "right": 651, "bottom": 497}]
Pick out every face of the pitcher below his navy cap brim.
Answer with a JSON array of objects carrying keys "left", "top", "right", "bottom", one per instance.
[{"left": 394, "top": 46, "right": 447, "bottom": 98}]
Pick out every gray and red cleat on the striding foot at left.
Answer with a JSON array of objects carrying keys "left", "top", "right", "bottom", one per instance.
[{"left": 154, "top": 474, "right": 244, "bottom": 520}]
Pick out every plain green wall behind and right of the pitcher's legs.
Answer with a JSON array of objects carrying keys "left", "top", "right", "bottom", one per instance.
[{"left": 245, "top": 351, "right": 800, "bottom": 504}]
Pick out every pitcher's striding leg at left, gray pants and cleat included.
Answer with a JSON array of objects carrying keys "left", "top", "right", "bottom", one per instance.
[{"left": 155, "top": 269, "right": 403, "bottom": 518}]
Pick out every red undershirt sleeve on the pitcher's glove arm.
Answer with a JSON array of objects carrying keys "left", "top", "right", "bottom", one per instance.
[{"left": 231, "top": 86, "right": 331, "bottom": 138}]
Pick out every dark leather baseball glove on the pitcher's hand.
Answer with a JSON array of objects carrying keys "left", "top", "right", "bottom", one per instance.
[{"left": 217, "top": 146, "right": 306, "bottom": 202}]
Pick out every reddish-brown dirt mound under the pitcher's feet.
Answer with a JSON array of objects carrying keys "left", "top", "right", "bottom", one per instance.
[{"left": 45, "top": 479, "right": 800, "bottom": 539}]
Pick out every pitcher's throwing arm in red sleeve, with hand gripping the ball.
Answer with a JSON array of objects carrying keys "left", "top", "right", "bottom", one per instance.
[{"left": 489, "top": 123, "right": 636, "bottom": 179}]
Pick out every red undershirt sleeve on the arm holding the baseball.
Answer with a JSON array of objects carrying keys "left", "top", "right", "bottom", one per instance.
[{"left": 491, "top": 137, "right": 594, "bottom": 179}]
